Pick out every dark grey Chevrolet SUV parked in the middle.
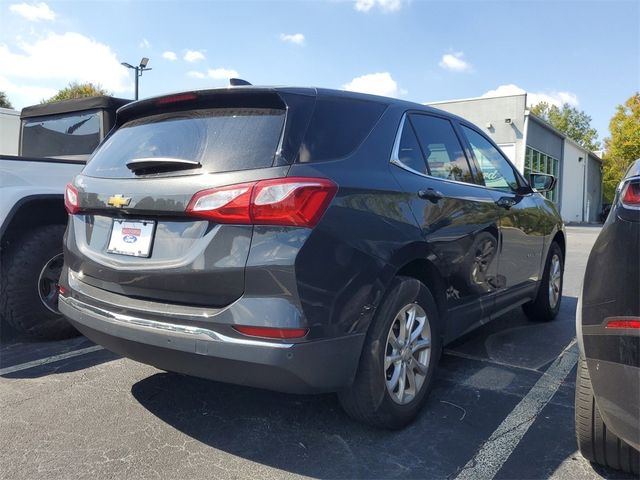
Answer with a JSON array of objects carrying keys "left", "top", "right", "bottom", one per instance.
[{"left": 60, "top": 86, "right": 565, "bottom": 428}]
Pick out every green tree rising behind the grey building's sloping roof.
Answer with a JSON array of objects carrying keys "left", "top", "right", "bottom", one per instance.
[{"left": 531, "top": 102, "right": 600, "bottom": 152}]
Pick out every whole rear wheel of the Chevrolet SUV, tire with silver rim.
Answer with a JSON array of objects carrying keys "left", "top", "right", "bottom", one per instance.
[{"left": 338, "top": 277, "right": 442, "bottom": 429}]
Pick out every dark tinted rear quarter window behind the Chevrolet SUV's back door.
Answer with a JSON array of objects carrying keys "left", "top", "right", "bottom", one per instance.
[{"left": 298, "top": 96, "right": 387, "bottom": 163}]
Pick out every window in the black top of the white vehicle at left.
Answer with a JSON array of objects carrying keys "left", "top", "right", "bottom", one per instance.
[{"left": 21, "top": 110, "right": 100, "bottom": 157}]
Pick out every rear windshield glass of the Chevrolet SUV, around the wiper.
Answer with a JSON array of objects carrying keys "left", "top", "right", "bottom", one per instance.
[{"left": 84, "top": 108, "right": 285, "bottom": 178}]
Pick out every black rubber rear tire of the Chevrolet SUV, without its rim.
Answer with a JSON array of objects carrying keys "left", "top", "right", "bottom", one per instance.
[{"left": 338, "top": 277, "right": 442, "bottom": 429}]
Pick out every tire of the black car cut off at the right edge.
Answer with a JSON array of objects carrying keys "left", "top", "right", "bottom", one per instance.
[{"left": 575, "top": 358, "right": 640, "bottom": 475}]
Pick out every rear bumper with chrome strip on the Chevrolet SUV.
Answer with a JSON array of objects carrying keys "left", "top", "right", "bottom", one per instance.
[{"left": 59, "top": 296, "right": 364, "bottom": 393}]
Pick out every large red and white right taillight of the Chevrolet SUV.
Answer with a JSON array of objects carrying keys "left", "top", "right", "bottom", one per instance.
[{"left": 186, "top": 177, "right": 338, "bottom": 227}]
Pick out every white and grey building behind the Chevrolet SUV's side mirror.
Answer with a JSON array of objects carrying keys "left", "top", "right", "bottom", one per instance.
[{"left": 429, "top": 94, "right": 602, "bottom": 223}]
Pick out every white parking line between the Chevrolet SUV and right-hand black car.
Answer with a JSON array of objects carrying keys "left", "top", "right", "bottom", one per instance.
[{"left": 455, "top": 340, "right": 579, "bottom": 480}]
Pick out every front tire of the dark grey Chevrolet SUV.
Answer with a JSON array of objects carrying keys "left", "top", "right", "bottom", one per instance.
[{"left": 522, "top": 242, "right": 564, "bottom": 322}]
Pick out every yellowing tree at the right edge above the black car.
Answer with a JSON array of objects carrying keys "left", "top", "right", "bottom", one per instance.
[{"left": 602, "top": 92, "right": 640, "bottom": 202}]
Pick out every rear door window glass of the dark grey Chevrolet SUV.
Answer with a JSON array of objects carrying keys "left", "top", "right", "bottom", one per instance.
[{"left": 410, "top": 114, "right": 475, "bottom": 183}]
